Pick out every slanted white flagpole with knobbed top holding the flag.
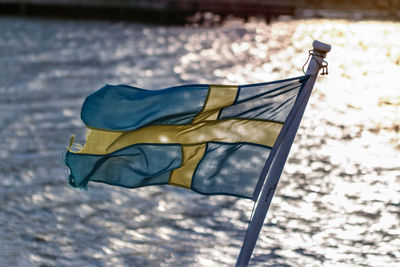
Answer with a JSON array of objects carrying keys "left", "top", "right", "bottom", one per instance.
[{"left": 235, "top": 41, "right": 331, "bottom": 267}]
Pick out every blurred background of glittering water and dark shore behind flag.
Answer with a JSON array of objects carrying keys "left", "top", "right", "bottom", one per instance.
[{"left": 0, "top": 0, "right": 400, "bottom": 266}]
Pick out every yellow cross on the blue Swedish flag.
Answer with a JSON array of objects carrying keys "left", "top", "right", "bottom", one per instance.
[{"left": 71, "top": 85, "right": 282, "bottom": 188}]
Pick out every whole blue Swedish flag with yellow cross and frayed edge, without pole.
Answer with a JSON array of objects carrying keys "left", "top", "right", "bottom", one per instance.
[{"left": 65, "top": 75, "right": 309, "bottom": 200}]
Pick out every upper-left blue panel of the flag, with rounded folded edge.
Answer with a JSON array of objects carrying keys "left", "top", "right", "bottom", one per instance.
[{"left": 81, "top": 85, "right": 208, "bottom": 131}]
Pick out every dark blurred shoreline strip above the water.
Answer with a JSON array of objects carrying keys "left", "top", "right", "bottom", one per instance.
[{"left": 0, "top": 1, "right": 400, "bottom": 25}]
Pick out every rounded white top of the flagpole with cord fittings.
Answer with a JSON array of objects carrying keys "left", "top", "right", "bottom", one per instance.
[{"left": 303, "top": 40, "right": 331, "bottom": 75}]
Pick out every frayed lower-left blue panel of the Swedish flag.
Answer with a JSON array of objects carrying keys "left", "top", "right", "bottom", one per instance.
[{"left": 65, "top": 144, "right": 182, "bottom": 191}]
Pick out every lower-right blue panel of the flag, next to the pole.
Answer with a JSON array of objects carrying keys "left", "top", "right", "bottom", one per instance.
[{"left": 192, "top": 142, "right": 271, "bottom": 199}]
